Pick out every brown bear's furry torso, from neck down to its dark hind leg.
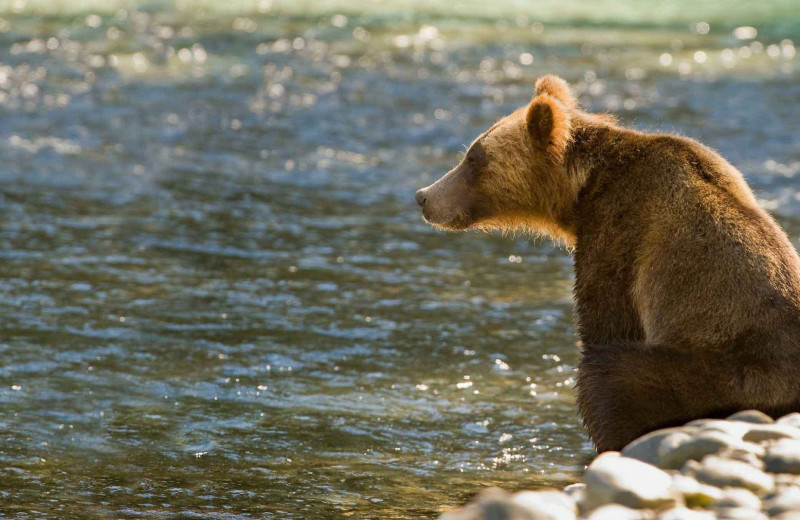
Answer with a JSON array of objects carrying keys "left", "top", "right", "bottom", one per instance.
[{"left": 575, "top": 129, "right": 800, "bottom": 348}]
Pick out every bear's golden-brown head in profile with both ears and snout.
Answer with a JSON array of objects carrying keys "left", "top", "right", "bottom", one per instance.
[{"left": 416, "top": 76, "right": 611, "bottom": 242}]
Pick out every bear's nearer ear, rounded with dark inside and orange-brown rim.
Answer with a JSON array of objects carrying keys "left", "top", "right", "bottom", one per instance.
[{"left": 526, "top": 94, "right": 571, "bottom": 162}]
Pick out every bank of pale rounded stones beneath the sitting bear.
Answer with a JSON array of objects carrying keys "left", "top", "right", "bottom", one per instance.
[{"left": 440, "top": 410, "right": 800, "bottom": 520}]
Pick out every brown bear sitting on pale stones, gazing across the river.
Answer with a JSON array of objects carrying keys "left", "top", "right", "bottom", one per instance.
[{"left": 416, "top": 76, "right": 800, "bottom": 451}]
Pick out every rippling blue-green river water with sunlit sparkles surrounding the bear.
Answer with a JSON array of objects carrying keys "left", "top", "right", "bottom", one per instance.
[{"left": 0, "top": 0, "right": 800, "bottom": 519}]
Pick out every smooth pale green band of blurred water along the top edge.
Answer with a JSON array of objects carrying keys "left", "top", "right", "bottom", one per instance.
[{"left": 0, "top": 0, "right": 800, "bottom": 25}]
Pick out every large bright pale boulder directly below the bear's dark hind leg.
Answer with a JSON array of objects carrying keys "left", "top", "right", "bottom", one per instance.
[{"left": 581, "top": 452, "right": 678, "bottom": 511}]
